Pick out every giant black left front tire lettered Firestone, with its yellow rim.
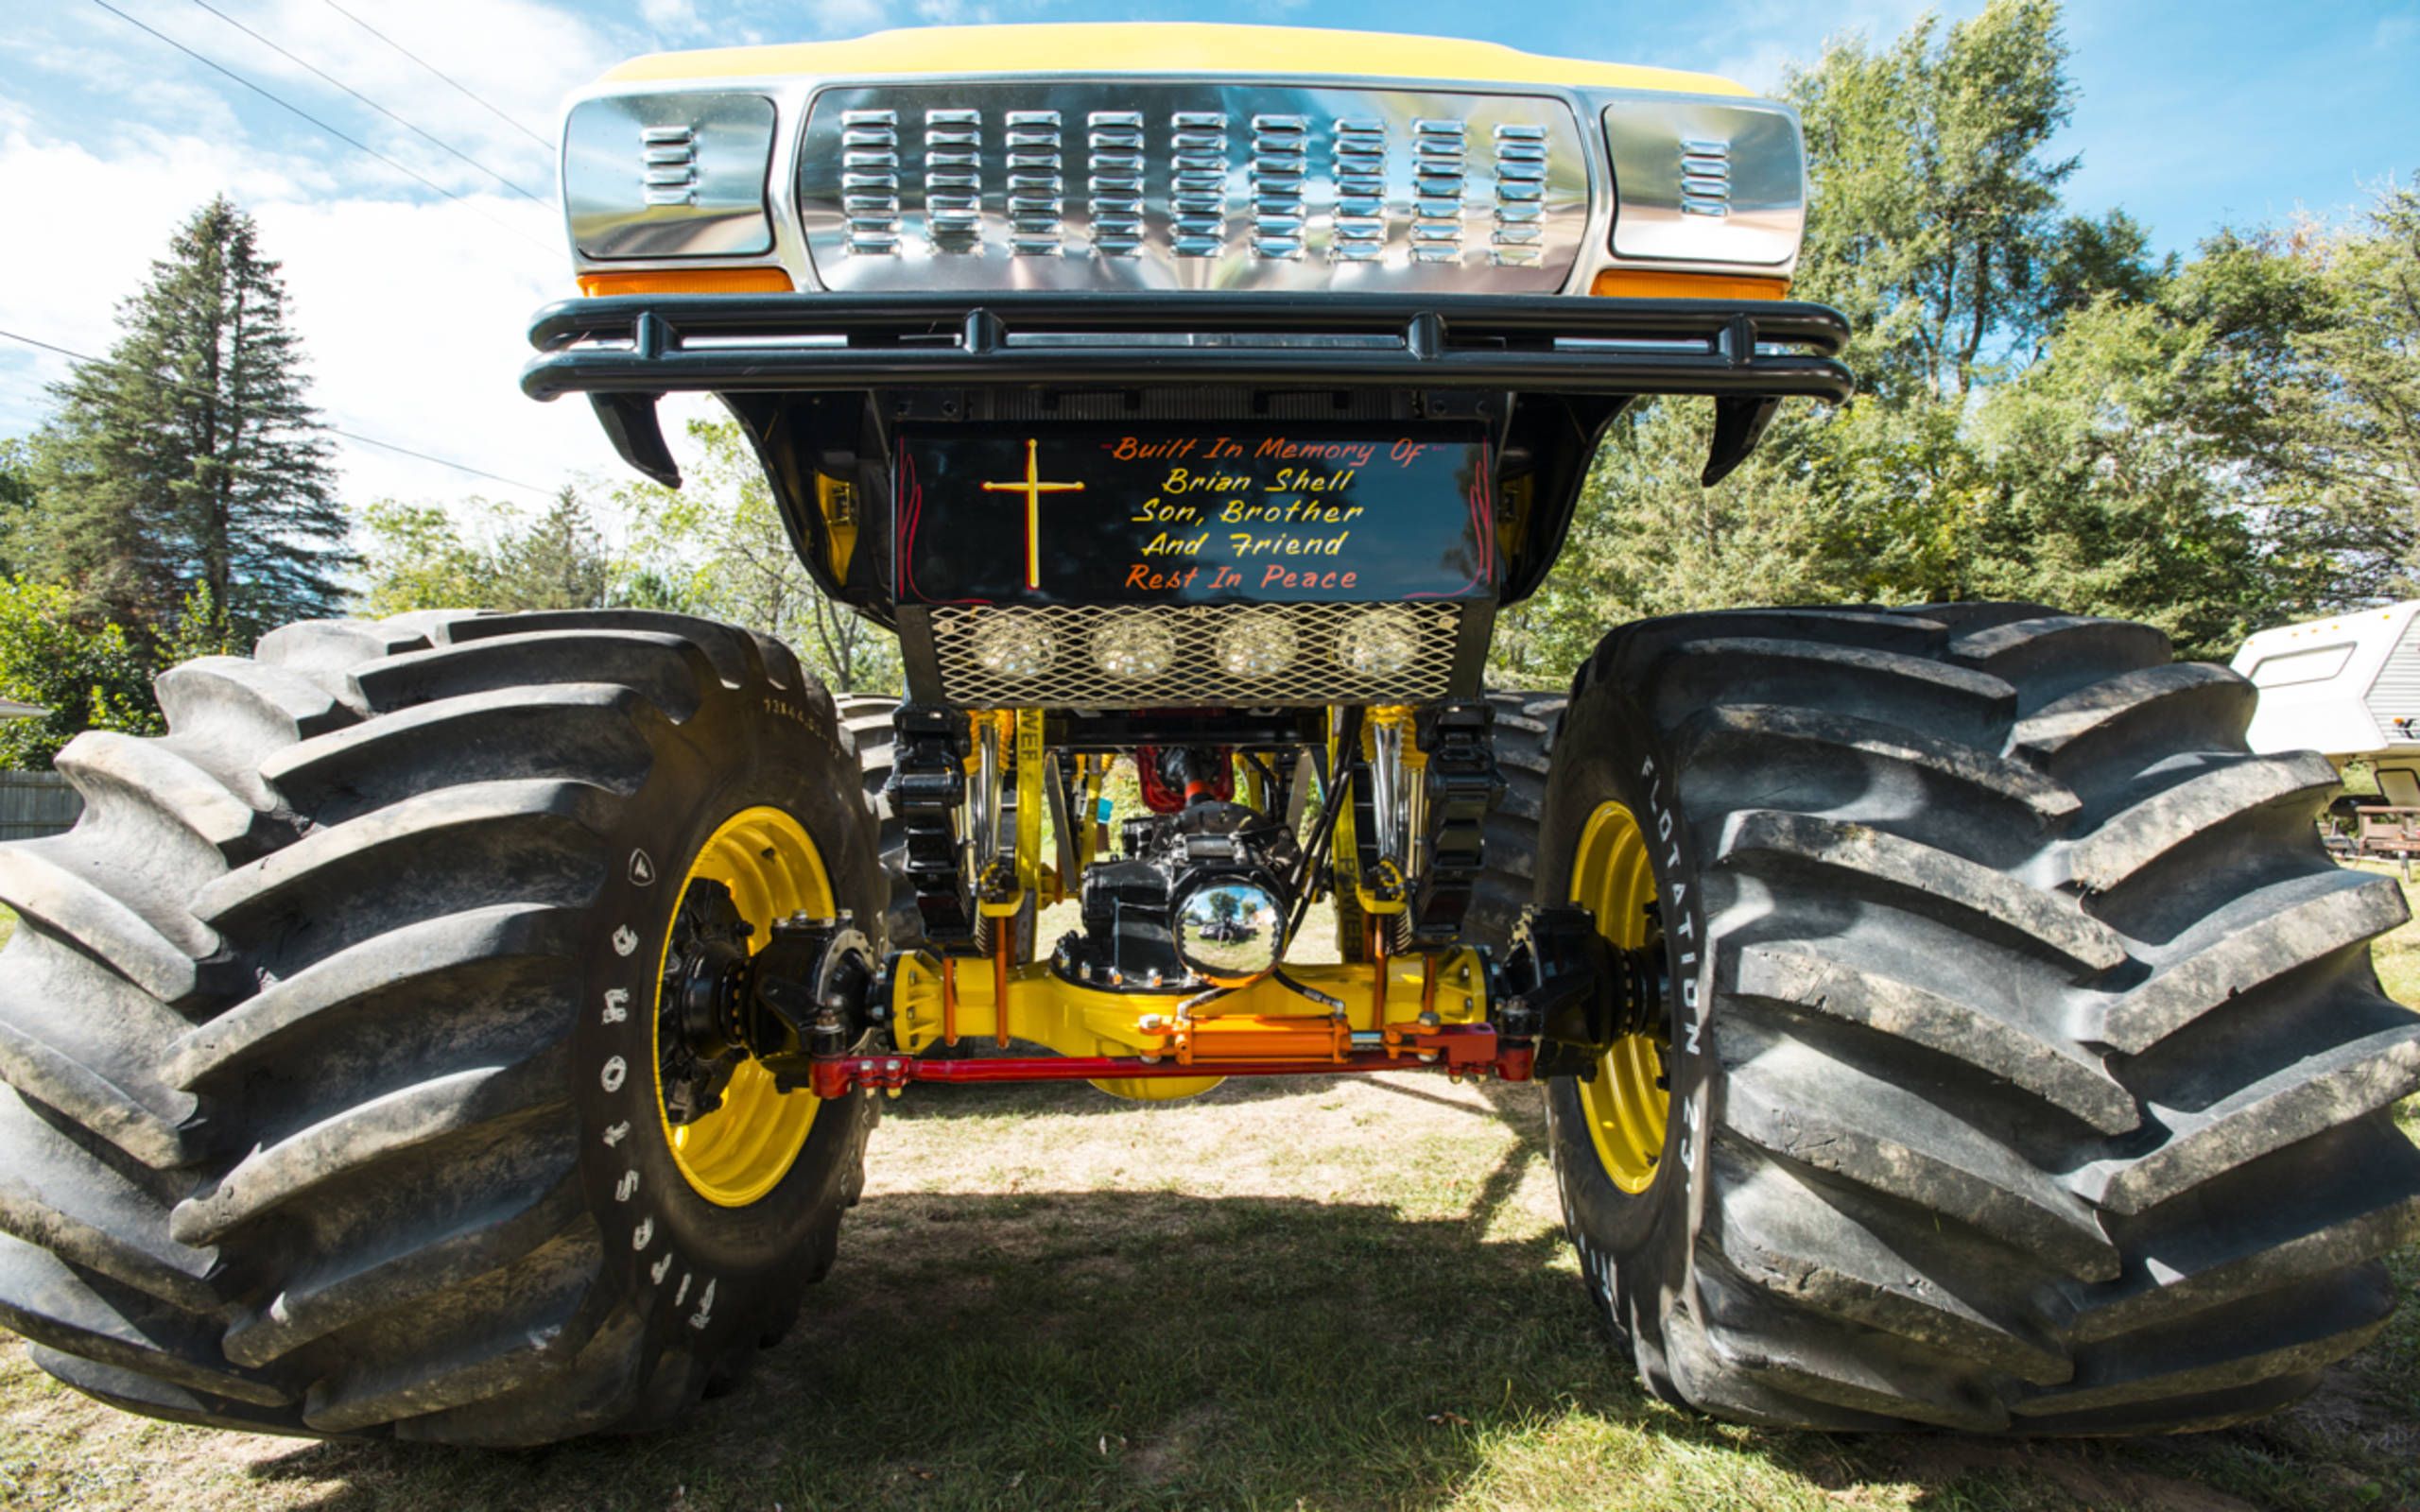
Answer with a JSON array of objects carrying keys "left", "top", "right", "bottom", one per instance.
[{"left": 0, "top": 612, "right": 883, "bottom": 1444}]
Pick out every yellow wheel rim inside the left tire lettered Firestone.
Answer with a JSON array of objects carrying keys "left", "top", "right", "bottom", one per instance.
[{"left": 656, "top": 808, "right": 833, "bottom": 1207}]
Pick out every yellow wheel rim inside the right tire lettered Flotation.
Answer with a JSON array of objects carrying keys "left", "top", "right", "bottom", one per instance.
[{"left": 1570, "top": 803, "right": 1672, "bottom": 1193}]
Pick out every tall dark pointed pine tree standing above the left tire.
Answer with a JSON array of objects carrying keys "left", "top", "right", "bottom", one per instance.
[{"left": 39, "top": 198, "right": 351, "bottom": 646}]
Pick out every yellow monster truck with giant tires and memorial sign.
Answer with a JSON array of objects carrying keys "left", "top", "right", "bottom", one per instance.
[{"left": 0, "top": 26, "right": 2420, "bottom": 1444}]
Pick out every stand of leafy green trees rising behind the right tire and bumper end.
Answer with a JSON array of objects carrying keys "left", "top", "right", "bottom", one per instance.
[{"left": 1494, "top": 0, "right": 2332, "bottom": 684}]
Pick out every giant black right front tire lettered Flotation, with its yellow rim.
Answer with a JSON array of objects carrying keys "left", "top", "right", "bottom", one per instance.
[{"left": 1474, "top": 605, "right": 2420, "bottom": 1435}]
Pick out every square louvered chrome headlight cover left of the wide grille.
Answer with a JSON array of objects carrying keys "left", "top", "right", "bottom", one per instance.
[{"left": 563, "top": 92, "right": 774, "bottom": 259}]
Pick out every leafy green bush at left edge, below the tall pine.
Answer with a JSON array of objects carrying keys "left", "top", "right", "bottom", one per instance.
[{"left": 0, "top": 578, "right": 164, "bottom": 772}]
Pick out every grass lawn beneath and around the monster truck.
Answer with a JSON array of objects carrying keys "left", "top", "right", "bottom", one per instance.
[{"left": 0, "top": 890, "right": 2420, "bottom": 1512}]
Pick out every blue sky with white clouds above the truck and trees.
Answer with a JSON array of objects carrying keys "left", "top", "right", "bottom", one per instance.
[{"left": 0, "top": 0, "right": 2420, "bottom": 501}]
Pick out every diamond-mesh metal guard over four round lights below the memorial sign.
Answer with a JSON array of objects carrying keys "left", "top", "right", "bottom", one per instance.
[{"left": 932, "top": 602, "right": 1461, "bottom": 709}]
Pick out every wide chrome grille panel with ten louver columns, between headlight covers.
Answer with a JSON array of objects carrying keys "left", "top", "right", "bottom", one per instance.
[{"left": 799, "top": 79, "right": 1587, "bottom": 293}]
